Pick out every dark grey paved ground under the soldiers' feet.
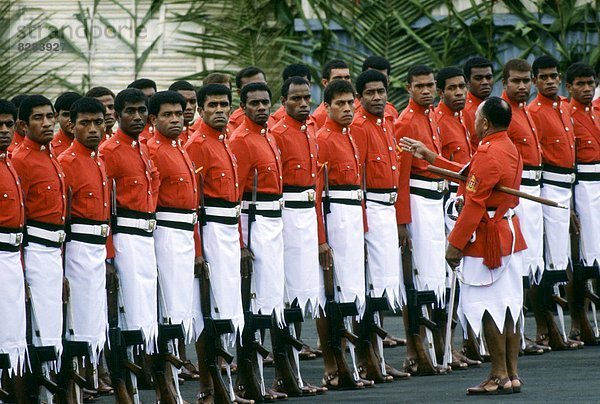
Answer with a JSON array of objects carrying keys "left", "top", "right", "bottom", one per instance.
[{"left": 95, "top": 317, "right": 600, "bottom": 404}]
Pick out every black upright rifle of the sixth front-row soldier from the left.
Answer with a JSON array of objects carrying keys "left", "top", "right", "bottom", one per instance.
[{"left": 196, "top": 174, "right": 235, "bottom": 403}]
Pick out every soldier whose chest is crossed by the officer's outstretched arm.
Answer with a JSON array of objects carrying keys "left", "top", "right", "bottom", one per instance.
[{"left": 395, "top": 65, "right": 446, "bottom": 373}]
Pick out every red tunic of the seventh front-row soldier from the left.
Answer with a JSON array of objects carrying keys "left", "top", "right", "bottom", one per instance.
[{"left": 231, "top": 117, "right": 283, "bottom": 199}]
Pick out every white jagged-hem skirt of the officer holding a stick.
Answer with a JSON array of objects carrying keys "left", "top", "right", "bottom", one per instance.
[{"left": 458, "top": 252, "right": 523, "bottom": 338}]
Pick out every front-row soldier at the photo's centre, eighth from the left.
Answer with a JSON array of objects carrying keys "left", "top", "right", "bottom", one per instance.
[{"left": 273, "top": 76, "right": 329, "bottom": 392}]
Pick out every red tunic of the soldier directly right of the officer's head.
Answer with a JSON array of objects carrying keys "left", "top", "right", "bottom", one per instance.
[{"left": 502, "top": 92, "right": 542, "bottom": 167}]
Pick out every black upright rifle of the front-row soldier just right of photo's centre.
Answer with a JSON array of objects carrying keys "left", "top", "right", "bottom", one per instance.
[{"left": 323, "top": 164, "right": 358, "bottom": 389}]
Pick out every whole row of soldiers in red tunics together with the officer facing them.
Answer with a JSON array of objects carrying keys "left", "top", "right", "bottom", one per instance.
[{"left": 0, "top": 52, "right": 600, "bottom": 403}]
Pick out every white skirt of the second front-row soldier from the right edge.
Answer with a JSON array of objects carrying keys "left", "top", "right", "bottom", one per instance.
[{"left": 541, "top": 184, "right": 571, "bottom": 270}]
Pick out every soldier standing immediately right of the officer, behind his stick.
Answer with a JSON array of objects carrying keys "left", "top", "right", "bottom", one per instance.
[{"left": 502, "top": 59, "right": 550, "bottom": 355}]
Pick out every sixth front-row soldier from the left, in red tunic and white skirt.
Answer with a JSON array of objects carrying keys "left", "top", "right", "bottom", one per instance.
[{"left": 185, "top": 84, "right": 244, "bottom": 402}]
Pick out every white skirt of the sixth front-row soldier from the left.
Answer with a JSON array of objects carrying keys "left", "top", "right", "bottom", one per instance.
[{"left": 192, "top": 222, "right": 246, "bottom": 346}]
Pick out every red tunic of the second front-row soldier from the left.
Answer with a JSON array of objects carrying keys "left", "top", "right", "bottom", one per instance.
[{"left": 13, "top": 138, "right": 66, "bottom": 225}]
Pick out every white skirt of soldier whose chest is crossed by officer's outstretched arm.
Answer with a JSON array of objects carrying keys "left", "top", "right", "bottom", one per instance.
[{"left": 408, "top": 194, "right": 446, "bottom": 307}]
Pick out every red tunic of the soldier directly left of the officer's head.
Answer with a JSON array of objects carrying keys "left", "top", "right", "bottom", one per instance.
[{"left": 435, "top": 102, "right": 473, "bottom": 164}]
